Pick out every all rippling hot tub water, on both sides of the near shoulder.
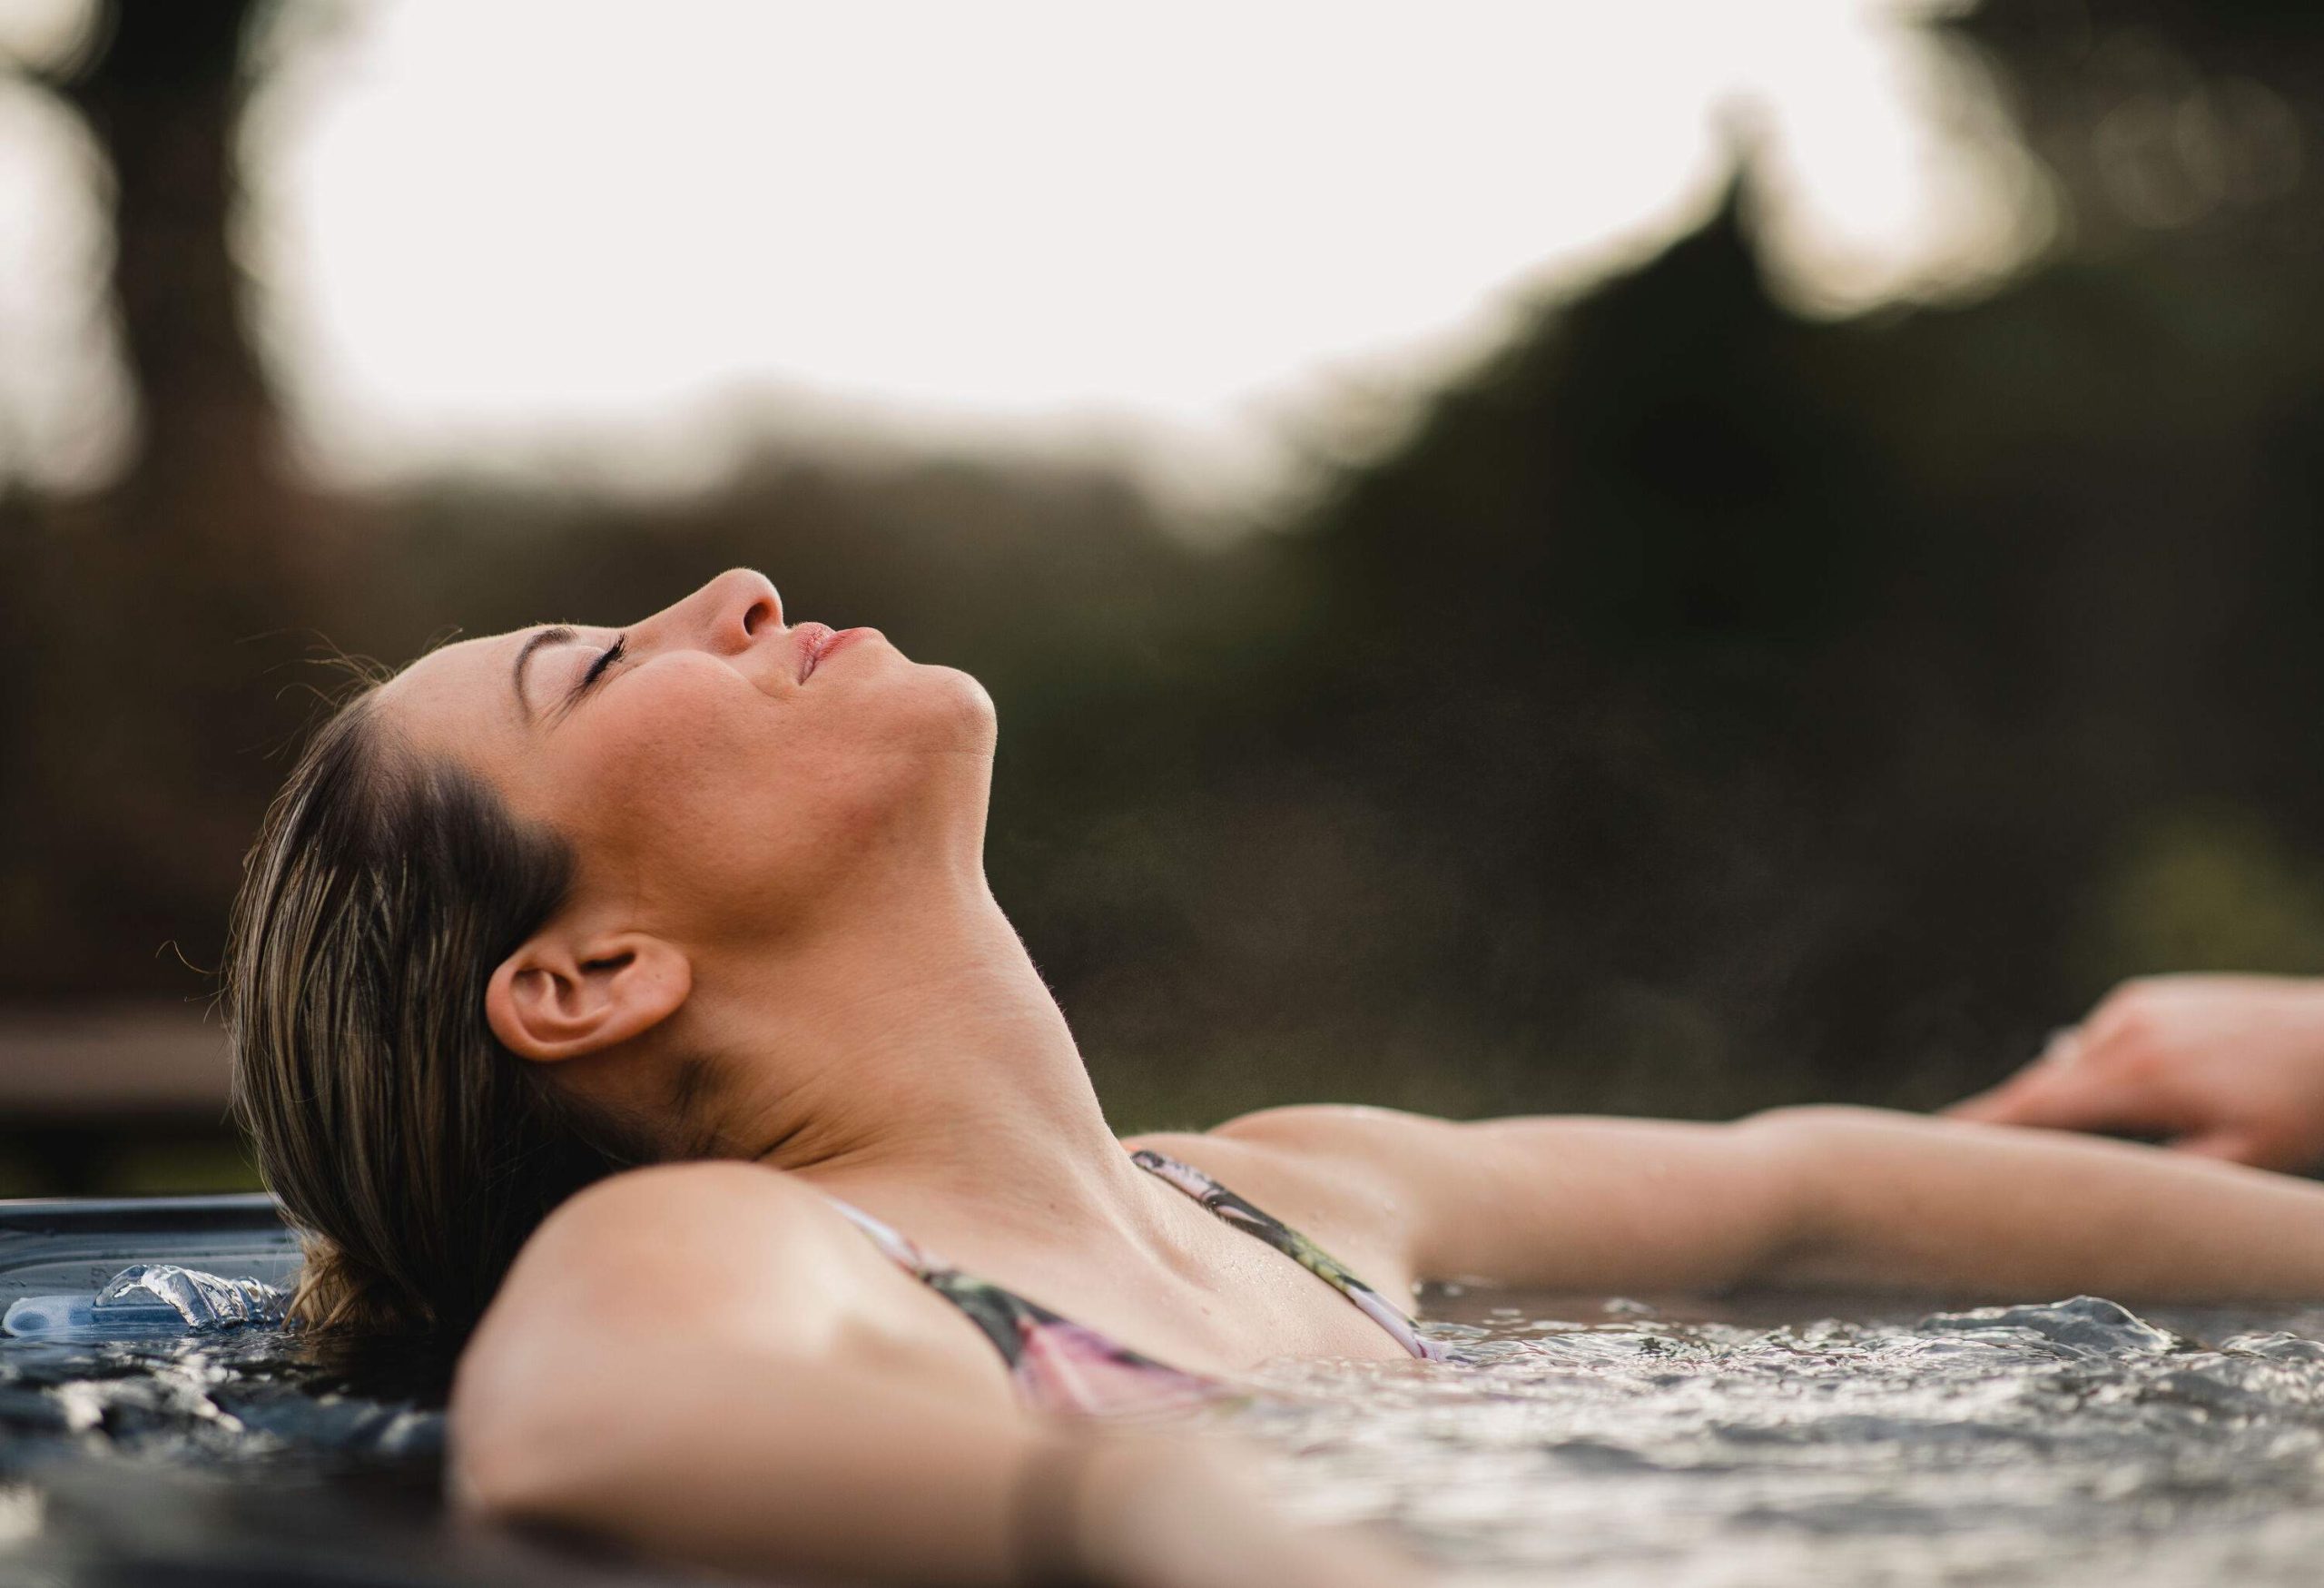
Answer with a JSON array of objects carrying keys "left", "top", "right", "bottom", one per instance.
[{"left": 14, "top": 1290, "right": 2324, "bottom": 1588}]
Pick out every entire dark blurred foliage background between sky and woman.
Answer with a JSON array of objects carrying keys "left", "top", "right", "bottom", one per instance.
[{"left": 0, "top": 0, "right": 2324, "bottom": 1171}]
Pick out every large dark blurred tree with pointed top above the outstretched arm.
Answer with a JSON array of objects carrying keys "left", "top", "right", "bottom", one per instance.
[{"left": 1059, "top": 46, "right": 2324, "bottom": 1129}]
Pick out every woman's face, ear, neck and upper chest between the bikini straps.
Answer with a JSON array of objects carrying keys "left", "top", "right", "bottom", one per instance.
[{"left": 381, "top": 569, "right": 1431, "bottom": 1367}]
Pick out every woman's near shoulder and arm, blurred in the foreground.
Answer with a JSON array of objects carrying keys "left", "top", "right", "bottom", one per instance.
[{"left": 451, "top": 1165, "right": 1408, "bottom": 1588}]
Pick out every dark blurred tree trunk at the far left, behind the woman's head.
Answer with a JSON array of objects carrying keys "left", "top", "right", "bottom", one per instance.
[{"left": 0, "top": 0, "right": 316, "bottom": 995}]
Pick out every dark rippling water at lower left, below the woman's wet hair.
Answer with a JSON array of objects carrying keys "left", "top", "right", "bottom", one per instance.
[{"left": 0, "top": 1327, "right": 700, "bottom": 1588}]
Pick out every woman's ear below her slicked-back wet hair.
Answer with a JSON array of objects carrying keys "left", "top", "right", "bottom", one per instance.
[{"left": 483, "top": 925, "right": 694, "bottom": 1060}]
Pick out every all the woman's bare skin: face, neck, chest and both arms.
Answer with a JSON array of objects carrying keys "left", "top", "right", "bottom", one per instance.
[{"left": 379, "top": 569, "right": 2324, "bottom": 1588}]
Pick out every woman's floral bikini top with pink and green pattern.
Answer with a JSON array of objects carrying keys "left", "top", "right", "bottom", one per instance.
[{"left": 830, "top": 1149, "right": 1443, "bottom": 1414}]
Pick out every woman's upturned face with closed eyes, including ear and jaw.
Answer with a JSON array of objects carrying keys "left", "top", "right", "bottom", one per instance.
[{"left": 381, "top": 569, "right": 1064, "bottom": 1180}]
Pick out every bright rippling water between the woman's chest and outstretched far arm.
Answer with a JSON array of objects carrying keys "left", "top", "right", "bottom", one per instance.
[{"left": 1229, "top": 1293, "right": 2324, "bottom": 1588}]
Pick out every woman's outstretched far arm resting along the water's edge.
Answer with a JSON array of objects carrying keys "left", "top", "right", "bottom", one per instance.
[{"left": 1220, "top": 1109, "right": 2324, "bottom": 1299}]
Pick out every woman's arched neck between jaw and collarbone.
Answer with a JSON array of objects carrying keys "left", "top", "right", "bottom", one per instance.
[{"left": 693, "top": 874, "right": 1150, "bottom": 1232}]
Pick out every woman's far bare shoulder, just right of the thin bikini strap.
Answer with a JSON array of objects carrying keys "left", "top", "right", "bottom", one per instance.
[{"left": 1125, "top": 1104, "right": 1452, "bottom": 1293}]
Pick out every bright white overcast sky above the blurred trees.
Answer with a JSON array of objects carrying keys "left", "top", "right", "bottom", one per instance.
[{"left": 0, "top": 0, "right": 2026, "bottom": 507}]
